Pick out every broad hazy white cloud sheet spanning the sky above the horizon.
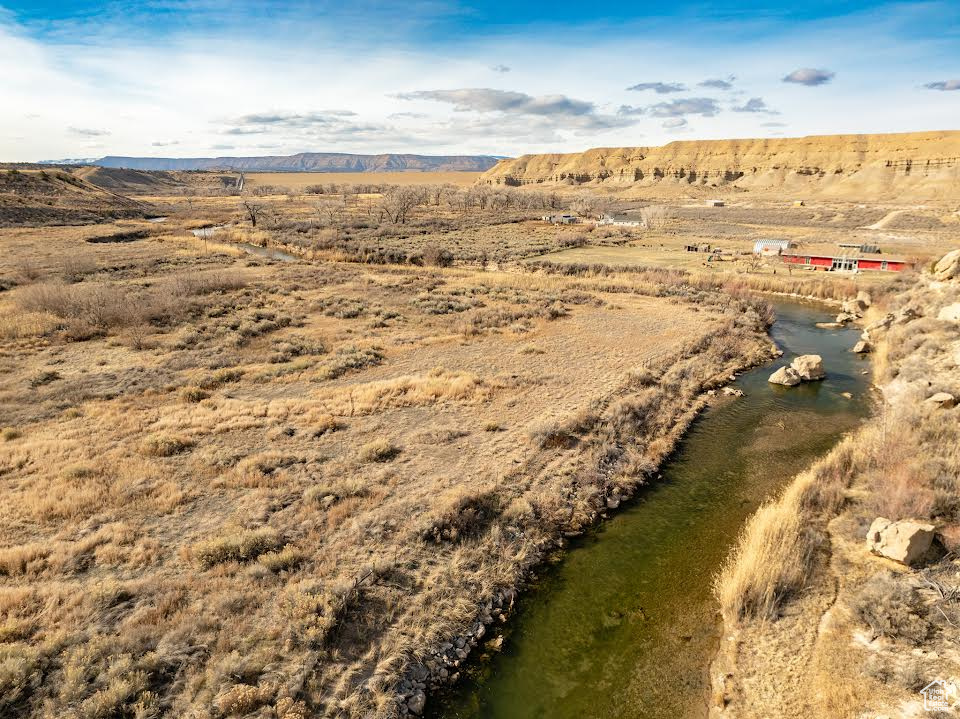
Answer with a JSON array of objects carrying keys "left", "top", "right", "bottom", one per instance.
[{"left": 0, "top": 0, "right": 960, "bottom": 160}]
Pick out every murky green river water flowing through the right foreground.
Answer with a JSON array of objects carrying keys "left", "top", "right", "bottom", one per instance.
[{"left": 428, "top": 302, "right": 869, "bottom": 719}]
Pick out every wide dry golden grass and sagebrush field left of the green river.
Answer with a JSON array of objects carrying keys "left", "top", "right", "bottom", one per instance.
[{"left": 0, "top": 169, "right": 944, "bottom": 719}]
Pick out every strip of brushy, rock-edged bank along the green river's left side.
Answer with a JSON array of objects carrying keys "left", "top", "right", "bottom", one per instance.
[{"left": 398, "top": 294, "right": 778, "bottom": 714}]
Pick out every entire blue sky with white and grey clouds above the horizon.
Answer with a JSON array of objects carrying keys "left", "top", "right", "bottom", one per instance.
[{"left": 0, "top": 0, "right": 960, "bottom": 161}]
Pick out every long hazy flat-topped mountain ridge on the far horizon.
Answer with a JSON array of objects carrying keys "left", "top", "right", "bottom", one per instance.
[{"left": 90, "top": 152, "right": 502, "bottom": 172}]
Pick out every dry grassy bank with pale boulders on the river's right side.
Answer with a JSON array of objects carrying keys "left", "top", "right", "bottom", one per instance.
[{"left": 710, "top": 252, "right": 960, "bottom": 719}]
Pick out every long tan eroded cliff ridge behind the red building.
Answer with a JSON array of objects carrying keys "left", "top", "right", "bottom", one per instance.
[{"left": 479, "top": 131, "right": 960, "bottom": 200}]
